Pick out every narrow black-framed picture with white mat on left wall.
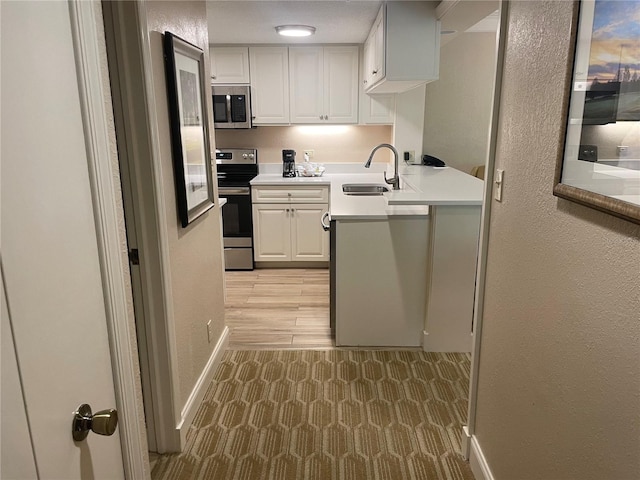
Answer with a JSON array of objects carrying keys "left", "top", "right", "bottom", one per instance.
[{"left": 163, "top": 32, "right": 214, "bottom": 228}]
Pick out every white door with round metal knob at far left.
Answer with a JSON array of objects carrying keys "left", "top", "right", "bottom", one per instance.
[{"left": 0, "top": 1, "right": 124, "bottom": 479}]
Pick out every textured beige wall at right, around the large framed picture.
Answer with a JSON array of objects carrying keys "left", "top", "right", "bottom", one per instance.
[{"left": 476, "top": 1, "right": 640, "bottom": 480}]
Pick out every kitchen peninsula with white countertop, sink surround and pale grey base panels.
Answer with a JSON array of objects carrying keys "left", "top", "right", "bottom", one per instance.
[{"left": 251, "top": 164, "right": 483, "bottom": 352}]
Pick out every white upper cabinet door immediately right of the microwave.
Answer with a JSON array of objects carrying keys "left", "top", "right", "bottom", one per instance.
[{"left": 249, "top": 47, "right": 290, "bottom": 125}]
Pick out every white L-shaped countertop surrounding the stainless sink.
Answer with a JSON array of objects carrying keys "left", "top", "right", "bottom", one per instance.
[{"left": 251, "top": 165, "right": 484, "bottom": 220}]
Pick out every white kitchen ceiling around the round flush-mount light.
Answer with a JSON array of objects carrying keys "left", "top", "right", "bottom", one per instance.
[{"left": 207, "top": 0, "right": 498, "bottom": 45}]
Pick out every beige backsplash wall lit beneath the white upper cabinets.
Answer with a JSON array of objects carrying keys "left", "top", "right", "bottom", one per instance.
[{"left": 214, "top": 125, "right": 393, "bottom": 164}]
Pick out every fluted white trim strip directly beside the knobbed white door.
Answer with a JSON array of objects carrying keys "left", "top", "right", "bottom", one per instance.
[{"left": 68, "top": 0, "right": 149, "bottom": 479}]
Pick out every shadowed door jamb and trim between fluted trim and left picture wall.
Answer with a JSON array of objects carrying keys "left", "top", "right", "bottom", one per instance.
[{"left": 102, "top": 0, "right": 186, "bottom": 453}]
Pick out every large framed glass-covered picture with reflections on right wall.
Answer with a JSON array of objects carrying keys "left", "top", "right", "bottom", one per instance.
[{"left": 553, "top": 0, "right": 640, "bottom": 223}]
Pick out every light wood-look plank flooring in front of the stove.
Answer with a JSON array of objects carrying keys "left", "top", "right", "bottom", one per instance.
[{"left": 225, "top": 269, "right": 335, "bottom": 350}]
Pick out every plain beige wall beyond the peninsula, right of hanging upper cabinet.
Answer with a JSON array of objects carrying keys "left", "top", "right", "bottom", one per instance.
[{"left": 423, "top": 33, "right": 496, "bottom": 172}]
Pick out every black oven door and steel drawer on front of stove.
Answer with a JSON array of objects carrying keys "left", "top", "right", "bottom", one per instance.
[{"left": 218, "top": 187, "right": 253, "bottom": 270}]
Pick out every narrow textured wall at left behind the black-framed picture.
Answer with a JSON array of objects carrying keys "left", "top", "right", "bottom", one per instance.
[{"left": 146, "top": 1, "right": 224, "bottom": 405}]
